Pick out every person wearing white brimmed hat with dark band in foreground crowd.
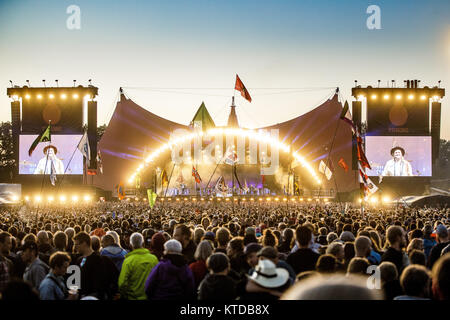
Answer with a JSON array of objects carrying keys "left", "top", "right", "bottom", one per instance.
[{"left": 240, "top": 259, "right": 291, "bottom": 301}]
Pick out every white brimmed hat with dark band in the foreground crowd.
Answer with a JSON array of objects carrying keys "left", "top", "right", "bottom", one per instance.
[{"left": 249, "top": 259, "right": 289, "bottom": 288}]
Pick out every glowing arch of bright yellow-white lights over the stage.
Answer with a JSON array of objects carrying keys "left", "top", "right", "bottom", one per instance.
[{"left": 128, "top": 128, "right": 321, "bottom": 184}]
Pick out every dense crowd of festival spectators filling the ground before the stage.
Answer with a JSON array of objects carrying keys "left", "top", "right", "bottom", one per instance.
[{"left": 0, "top": 201, "right": 450, "bottom": 301}]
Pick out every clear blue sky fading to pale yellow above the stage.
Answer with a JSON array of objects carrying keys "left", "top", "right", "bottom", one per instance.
[{"left": 0, "top": 0, "right": 450, "bottom": 139}]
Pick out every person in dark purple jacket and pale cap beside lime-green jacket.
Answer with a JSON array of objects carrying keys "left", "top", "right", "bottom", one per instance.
[{"left": 145, "top": 239, "right": 195, "bottom": 300}]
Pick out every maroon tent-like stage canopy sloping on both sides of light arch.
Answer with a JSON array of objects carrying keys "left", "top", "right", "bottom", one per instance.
[{"left": 94, "top": 94, "right": 358, "bottom": 192}]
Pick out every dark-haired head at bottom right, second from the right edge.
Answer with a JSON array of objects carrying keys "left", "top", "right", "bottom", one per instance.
[{"left": 394, "top": 264, "right": 431, "bottom": 300}]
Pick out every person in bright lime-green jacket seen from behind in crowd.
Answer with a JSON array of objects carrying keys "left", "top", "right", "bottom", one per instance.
[{"left": 118, "top": 232, "right": 158, "bottom": 300}]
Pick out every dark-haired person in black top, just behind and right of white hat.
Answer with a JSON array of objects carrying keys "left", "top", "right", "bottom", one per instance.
[{"left": 286, "top": 226, "right": 319, "bottom": 274}]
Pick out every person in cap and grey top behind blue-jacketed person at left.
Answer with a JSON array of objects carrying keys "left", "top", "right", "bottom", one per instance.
[{"left": 21, "top": 241, "right": 50, "bottom": 290}]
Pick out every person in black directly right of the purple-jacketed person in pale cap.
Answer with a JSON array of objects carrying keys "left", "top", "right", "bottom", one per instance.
[{"left": 198, "top": 252, "right": 237, "bottom": 301}]
